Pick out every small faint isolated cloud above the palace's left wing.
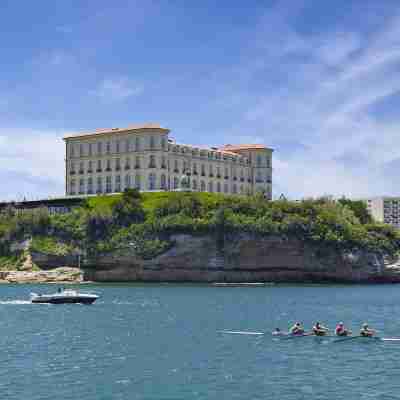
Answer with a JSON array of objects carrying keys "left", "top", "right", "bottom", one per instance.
[{"left": 92, "top": 78, "right": 143, "bottom": 102}]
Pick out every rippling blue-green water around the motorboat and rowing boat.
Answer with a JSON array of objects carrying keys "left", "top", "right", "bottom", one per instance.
[{"left": 0, "top": 285, "right": 400, "bottom": 400}]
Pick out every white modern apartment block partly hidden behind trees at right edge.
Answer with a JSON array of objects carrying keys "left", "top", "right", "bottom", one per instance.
[{"left": 365, "top": 197, "right": 400, "bottom": 228}]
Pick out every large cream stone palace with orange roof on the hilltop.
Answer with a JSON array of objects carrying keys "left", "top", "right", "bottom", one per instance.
[{"left": 64, "top": 124, "right": 273, "bottom": 199}]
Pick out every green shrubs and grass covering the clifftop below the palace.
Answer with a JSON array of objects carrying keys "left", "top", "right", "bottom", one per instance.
[{"left": 0, "top": 190, "right": 400, "bottom": 258}]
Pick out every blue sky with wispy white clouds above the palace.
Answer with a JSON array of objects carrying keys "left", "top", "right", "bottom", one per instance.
[{"left": 0, "top": 0, "right": 400, "bottom": 200}]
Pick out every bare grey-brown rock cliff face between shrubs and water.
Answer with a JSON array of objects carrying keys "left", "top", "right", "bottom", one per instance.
[{"left": 66, "top": 234, "right": 400, "bottom": 283}]
